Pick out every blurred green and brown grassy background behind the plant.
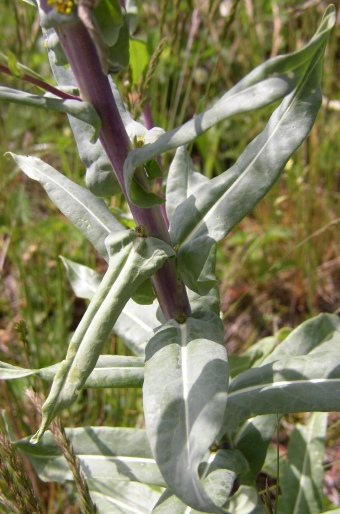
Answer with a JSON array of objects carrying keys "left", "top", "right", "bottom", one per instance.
[{"left": 0, "top": 0, "right": 340, "bottom": 513}]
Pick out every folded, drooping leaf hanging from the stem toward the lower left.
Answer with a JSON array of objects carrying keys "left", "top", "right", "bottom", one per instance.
[{"left": 32, "top": 230, "right": 174, "bottom": 442}]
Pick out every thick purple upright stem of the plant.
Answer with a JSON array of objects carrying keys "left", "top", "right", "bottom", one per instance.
[{"left": 41, "top": 6, "right": 191, "bottom": 321}]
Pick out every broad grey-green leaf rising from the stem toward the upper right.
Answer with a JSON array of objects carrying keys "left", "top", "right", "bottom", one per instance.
[{"left": 170, "top": 36, "right": 330, "bottom": 292}]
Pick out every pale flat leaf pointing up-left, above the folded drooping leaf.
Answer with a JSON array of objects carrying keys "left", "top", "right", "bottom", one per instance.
[{"left": 6, "top": 152, "right": 123, "bottom": 260}]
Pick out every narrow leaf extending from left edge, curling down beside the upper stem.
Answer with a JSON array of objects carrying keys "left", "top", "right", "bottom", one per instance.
[{"left": 0, "top": 86, "right": 101, "bottom": 140}]
